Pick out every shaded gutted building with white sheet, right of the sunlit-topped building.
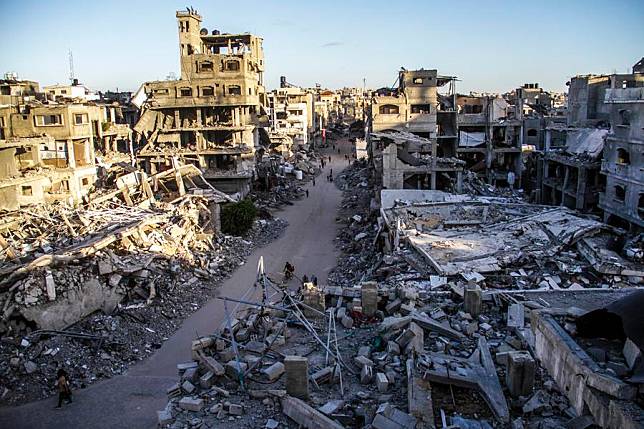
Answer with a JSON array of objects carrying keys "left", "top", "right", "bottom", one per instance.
[{"left": 456, "top": 94, "right": 523, "bottom": 187}]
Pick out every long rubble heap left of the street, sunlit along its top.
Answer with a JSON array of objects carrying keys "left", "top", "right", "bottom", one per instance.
[{"left": 0, "top": 163, "right": 286, "bottom": 403}]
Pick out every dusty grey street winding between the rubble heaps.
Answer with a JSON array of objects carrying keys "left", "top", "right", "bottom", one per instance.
[{"left": 0, "top": 141, "right": 350, "bottom": 429}]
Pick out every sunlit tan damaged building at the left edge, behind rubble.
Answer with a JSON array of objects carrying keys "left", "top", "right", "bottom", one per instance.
[{"left": 0, "top": 79, "right": 133, "bottom": 210}]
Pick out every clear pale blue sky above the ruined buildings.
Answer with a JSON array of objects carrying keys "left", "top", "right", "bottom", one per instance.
[{"left": 0, "top": 0, "right": 644, "bottom": 93}]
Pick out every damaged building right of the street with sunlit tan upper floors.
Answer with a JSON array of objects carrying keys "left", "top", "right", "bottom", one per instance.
[{"left": 368, "top": 70, "right": 462, "bottom": 189}]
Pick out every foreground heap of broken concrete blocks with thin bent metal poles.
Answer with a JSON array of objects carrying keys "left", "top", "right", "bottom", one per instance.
[{"left": 158, "top": 268, "right": 588, "bottom": 429}]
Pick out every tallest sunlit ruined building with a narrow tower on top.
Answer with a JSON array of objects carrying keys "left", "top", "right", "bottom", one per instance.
[{"left": 134, "top": 9, "right": 267, "bottom": 195}]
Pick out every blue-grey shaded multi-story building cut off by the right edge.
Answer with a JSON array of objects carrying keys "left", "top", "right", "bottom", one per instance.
[{"left": 599, "top": 67, "right": 644, "bottom": 231}]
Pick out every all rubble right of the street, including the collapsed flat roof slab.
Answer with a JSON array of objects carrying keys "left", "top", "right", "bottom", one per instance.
[{"left": 158, "top": 153, "right": 641, "bottom": 429}]
